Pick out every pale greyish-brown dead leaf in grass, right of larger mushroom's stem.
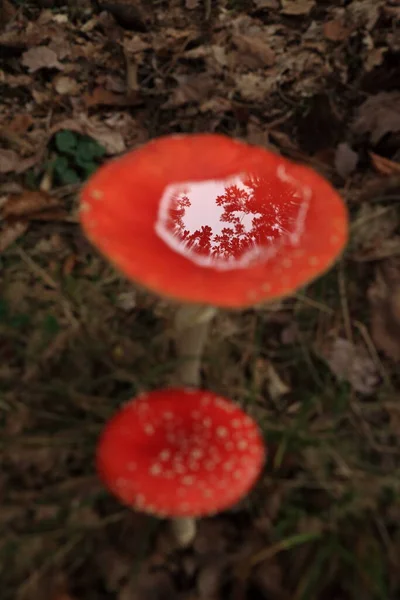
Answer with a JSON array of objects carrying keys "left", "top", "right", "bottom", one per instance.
[{"left": 320, "top": 337, "right": 380, "bottom": 396}]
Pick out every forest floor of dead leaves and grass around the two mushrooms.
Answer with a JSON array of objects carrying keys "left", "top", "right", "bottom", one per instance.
[{"left": 0, "top": 0, "right": 400, "bottom": 600}]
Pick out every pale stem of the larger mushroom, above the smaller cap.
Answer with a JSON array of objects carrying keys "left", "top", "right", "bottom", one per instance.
[{"left": 174, "top": 304, "right": 217, "bottom": 387}]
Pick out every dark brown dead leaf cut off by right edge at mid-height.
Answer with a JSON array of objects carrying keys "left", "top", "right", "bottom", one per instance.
[{"left": 368, "top": 266, "right": 400, "bottom": 361}]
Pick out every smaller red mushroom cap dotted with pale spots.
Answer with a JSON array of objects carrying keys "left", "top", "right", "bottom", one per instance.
[{"left": 97, "top": 389, "right": 265, "bottom": 517}]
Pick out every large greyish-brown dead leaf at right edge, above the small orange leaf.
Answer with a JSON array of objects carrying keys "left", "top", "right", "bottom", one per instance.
[{"left": 353, "top": 92, "right": 400, "bottom": 144}]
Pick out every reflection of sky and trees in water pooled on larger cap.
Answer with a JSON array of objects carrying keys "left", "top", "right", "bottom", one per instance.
[{"left": 161, "top": 175, "right": 304, "bottom": 264}]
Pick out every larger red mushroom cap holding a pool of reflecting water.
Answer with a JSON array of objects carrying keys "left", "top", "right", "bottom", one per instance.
[{"left": 81, "top": 134, "right": 348, "bottom": 308}]
